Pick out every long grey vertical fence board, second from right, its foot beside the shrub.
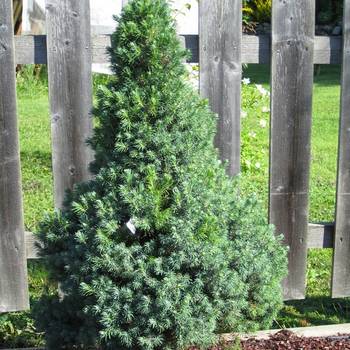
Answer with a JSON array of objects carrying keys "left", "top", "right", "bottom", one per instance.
[{"left": 269, "top": 0, "right": 315, "bottom": 300}]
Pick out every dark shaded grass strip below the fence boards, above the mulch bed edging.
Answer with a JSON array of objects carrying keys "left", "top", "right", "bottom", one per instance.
[{"left": 274, "top": 297, "right": 350, "bottom": 328}]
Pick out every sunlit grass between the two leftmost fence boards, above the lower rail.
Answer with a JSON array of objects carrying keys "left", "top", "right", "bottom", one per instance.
[{"left": 18, "top": 85, "right": 53, "bottom": 231}]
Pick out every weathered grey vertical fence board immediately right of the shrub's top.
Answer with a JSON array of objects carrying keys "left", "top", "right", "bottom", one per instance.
[{"left": 199, "top": 0, "right": 242, "bottom": 175}]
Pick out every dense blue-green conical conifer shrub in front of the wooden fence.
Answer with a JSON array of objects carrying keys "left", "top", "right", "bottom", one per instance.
[{"left": 36, "top": 0, "right": 286, "bottom": 350}]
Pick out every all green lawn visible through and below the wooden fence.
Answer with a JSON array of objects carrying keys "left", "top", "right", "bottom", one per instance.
[{"left": 0, "top": 65, "right": 350, "bottom": 347}]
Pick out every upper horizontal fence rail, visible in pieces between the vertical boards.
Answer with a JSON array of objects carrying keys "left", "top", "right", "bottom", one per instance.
[{"left": 15, "top": 34, "right": 342, "bottom": 64}]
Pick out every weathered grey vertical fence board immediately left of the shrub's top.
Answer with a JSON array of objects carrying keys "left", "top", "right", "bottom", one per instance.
[{"left": 46, "top": 0, "right": 92, "bottom": 207}]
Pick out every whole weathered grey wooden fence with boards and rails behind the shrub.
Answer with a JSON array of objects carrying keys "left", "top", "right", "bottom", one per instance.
[{"left": 0, "top": 0, "right": 350, "bottom": 312}]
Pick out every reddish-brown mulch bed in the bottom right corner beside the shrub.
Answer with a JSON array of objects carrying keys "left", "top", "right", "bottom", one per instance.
[{"left": 190, "top": 330, "right": 350, "bottom": 350}]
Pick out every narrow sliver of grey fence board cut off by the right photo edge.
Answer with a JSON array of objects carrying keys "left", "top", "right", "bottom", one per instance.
[{"left": 332, "top": 0, "right": 350, "bottom": 298}]
